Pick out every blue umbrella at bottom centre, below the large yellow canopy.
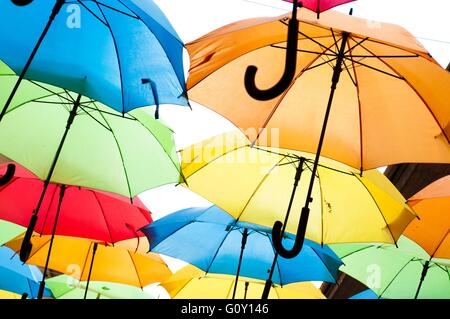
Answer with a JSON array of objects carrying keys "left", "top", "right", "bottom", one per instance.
[{"left": 141, "top": 206, "right": 342, "bottom": 298}]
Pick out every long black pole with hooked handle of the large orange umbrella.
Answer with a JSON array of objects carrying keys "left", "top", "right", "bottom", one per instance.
[{"left": 272, "top": 32, "right": 350, "bottom": 258}]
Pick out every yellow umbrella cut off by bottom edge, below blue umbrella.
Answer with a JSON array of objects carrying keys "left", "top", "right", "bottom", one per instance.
[{"left": 161, "top": 265, "right": 325, "bottom": 299}]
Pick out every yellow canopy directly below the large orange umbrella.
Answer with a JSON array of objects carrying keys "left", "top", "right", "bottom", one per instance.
[{"left": 181, "top": 132, "right": 415, "bottom": 243}]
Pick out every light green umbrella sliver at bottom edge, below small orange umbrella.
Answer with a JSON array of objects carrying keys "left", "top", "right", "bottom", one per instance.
[{"left": 46, "top": 275, "right": 155, "bottom": 299}]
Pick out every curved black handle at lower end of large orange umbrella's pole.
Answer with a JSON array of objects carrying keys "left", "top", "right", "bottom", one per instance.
[{"left": 272, "top": 207, "right": 309, "bottom": 259}]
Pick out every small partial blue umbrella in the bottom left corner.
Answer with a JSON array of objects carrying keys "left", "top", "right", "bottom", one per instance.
[{"left": 0, "top": 246, "right": 52, "bottom": 298}]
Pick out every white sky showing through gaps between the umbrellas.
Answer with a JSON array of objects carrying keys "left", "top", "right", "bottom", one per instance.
[{"left": 140, "top": 0, "right": 450, "bottom": 298}]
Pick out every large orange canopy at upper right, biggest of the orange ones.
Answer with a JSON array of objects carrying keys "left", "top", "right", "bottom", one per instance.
[{"left": 186, "top": 9, "right": 450, "bottom": 170}]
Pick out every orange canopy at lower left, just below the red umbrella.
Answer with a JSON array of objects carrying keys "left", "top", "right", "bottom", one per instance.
[{"left": 7, "top": 236, "right": 171, "bottom": 288}]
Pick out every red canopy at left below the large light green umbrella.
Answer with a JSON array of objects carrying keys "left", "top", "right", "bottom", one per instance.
[{"left": 0, "top": 164, "right": 152, "bottom": 243}]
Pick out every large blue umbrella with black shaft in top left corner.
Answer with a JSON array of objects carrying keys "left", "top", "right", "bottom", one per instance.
[{"left": 0, "top": 0, "right": 188, "bottom": 121}]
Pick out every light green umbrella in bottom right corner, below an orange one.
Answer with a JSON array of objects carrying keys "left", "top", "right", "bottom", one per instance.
[{"left": 330, "top": 236, "right": 450, "bottom": 299}]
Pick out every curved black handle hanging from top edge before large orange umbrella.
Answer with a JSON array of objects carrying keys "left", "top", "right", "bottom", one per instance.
[{"left": 244, "top": 0, "right": 302, "bottom": 101}]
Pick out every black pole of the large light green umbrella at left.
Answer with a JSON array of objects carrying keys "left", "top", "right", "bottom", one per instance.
[{"left": 19, "top": 94, "right": 81, "bottom": 262}]
